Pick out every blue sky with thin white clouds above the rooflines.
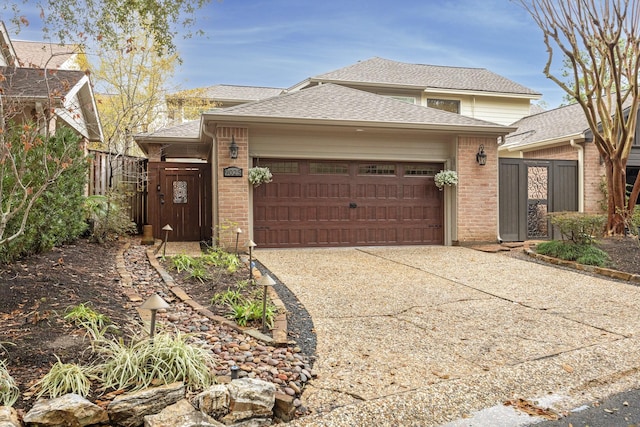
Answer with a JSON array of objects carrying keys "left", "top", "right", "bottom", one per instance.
[{"left": 5, "top": 0, "right": 563, "bottom": 108}]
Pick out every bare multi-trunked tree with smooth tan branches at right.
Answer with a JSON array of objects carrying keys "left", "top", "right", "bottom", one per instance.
[{"left": 516, "top": 0, "right": 640, "bottom": 234}]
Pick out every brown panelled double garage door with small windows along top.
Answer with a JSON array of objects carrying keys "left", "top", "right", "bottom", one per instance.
[{"left": 253, "top": 159, "right": 444, "bottom": 247}]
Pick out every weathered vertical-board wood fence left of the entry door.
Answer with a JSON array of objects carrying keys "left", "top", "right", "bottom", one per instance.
[{"left": 89, "top": 150, "right": 147, "bottom": 231}]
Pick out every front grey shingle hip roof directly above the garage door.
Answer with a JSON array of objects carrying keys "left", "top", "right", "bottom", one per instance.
[{"left": 204, "top": 83, "right": 510, "bottom": 129}]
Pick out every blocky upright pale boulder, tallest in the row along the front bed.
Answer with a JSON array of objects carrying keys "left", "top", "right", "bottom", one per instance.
[{"left": 221, "top": 378, "right": 276, "bottom": 424}]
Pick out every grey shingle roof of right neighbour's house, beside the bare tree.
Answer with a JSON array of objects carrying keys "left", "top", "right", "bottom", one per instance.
[{"left": 503, "top": 104, "right": 589, "bottom": 148}]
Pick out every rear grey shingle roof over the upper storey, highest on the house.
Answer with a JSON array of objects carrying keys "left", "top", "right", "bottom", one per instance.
[{"left": 304, "top": 57, "right": 540, "bottom": 97}]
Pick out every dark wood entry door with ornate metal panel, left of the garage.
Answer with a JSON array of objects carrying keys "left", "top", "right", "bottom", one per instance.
[{"left": 159, "top": 167, "right": 204, "bottom": 241}]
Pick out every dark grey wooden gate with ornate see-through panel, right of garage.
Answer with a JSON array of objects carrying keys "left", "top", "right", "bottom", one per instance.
[{"left": 499, "top": 159, "right": 578, "bottom": 242}]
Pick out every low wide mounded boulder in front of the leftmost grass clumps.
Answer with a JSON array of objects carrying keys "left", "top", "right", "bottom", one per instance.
[{"left": 23, "top": 393, "right": 109, "bottom": 427}]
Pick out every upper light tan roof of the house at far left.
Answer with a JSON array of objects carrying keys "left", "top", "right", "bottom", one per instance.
[{"left": 11, "top": 40, "right": 78, "bottom": 70}]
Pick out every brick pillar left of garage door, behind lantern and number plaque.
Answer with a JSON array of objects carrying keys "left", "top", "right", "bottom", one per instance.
[{"left": 218, "top": 127, "right": 250, "bottom": 248}]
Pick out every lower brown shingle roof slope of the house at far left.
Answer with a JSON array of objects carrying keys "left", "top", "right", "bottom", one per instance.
[{"left": 0, "top": 67, "right": 85, "bottom": 98}]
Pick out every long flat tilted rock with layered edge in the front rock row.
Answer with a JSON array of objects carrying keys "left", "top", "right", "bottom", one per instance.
[{"left": 107, "top": 382, "right": 185, "bottom": 427}]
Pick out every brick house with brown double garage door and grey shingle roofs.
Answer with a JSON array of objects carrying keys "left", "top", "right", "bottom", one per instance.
[{"left": 136, "top": 58, "right": 540, "bottom": 247}]
